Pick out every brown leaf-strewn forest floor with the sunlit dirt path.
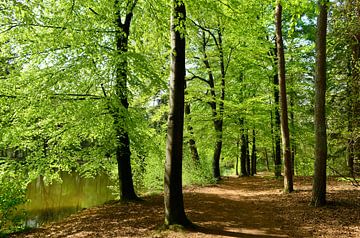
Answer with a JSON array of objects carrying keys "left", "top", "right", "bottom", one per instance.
[{"left": 11, "top": 175, "right": 360, "bottom": 238}]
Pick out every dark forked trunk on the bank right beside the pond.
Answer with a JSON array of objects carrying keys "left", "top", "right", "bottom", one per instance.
[{"left": 112, "top": 0, "right": 138, "bottom": 200}]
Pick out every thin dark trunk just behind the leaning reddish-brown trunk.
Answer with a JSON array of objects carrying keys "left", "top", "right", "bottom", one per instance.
[{"left": 273, "top": 48, "right": 281, "bottom": 178}]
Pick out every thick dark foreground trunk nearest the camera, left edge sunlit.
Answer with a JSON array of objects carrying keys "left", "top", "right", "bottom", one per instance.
[{"left": 164, "top": 0, "right": 191, "bottom": 226}]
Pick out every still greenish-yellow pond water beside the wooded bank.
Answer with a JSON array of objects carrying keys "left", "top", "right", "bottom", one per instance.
[{"left": 25, "top": 173, "right": 116, "bottom": 227}]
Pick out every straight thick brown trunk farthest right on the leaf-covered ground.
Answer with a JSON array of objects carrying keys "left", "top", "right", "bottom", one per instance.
[{"left": 311, "top": 0, "right": 328, "bottom": 207}]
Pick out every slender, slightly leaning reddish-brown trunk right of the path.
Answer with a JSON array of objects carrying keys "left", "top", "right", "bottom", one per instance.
[{"left": 275, "top": 0, "right": 294, "bottom": 193}]
